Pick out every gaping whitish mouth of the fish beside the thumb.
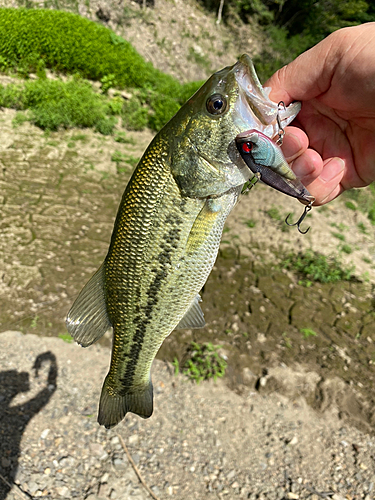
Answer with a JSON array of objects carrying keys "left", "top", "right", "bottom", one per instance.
[{"left": 233, "top": 54, "right": 301, "bottom": 139}]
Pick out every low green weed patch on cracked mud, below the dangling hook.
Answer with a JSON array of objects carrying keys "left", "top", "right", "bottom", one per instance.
[{"left": 281, "top": 250, "right": 354, "bottom": 283}]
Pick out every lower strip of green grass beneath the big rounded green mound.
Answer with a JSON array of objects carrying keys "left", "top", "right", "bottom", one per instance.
[{"left": 0, "top": 76, "right": 198, "bottom": 134}]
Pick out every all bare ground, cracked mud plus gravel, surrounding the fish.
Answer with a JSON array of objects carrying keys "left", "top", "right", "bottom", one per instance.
[{"left": 0, "top": 110, "right": 375, "bottom": 500}]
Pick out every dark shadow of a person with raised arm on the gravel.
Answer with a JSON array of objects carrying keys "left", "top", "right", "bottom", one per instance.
[{"left": 0, "top": 351, "right": 57, "bottom": 500}]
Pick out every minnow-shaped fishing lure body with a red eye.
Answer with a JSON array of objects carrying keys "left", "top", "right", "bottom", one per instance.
[{"left": 235, "top": 129, "right": 315, "bottom": 204}]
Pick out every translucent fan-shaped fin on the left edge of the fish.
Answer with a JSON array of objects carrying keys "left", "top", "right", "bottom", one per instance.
[{"left": 66, "top": 264, "right": 112, "bottom": 347}]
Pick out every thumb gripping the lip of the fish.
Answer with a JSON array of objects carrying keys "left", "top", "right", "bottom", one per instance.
[{"left": 264, "top": 33, "right": 340, "bottom": 105}]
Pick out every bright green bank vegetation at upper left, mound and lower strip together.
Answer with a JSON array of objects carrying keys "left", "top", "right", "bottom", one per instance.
[{"left": 0, "top": 9, "right": 201, "bottom": 134}]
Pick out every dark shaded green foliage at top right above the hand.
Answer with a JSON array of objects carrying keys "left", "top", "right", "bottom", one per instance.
[{"left": 201, "top": 0, "right": 375, "bottom": 80}]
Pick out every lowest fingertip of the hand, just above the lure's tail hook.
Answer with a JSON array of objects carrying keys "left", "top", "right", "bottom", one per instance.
[{"left": 306, "top": 158, "right": 345, "bottom": 205}]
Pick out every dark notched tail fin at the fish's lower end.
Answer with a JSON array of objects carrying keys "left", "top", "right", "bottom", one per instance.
[{"left": 98, "top": 375, "right": 154, "bottom": 429}]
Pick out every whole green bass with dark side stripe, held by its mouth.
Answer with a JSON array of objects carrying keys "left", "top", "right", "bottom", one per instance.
[{"left": 66, "top": 54, "right": 300, "bottom": 428}]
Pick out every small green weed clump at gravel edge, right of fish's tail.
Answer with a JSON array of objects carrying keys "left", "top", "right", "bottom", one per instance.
[{"left": 177, "top": 342, "right": 227, "bottom": 384}]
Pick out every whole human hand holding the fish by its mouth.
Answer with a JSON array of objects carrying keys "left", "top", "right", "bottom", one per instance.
[{"left": 264, "top": 23, "right": 375, "bottom": 205}]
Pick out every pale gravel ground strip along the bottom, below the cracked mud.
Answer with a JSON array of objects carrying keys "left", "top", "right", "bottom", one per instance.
[{"left": 0, "top": 332, "right": 375, "bottom": 500}]
